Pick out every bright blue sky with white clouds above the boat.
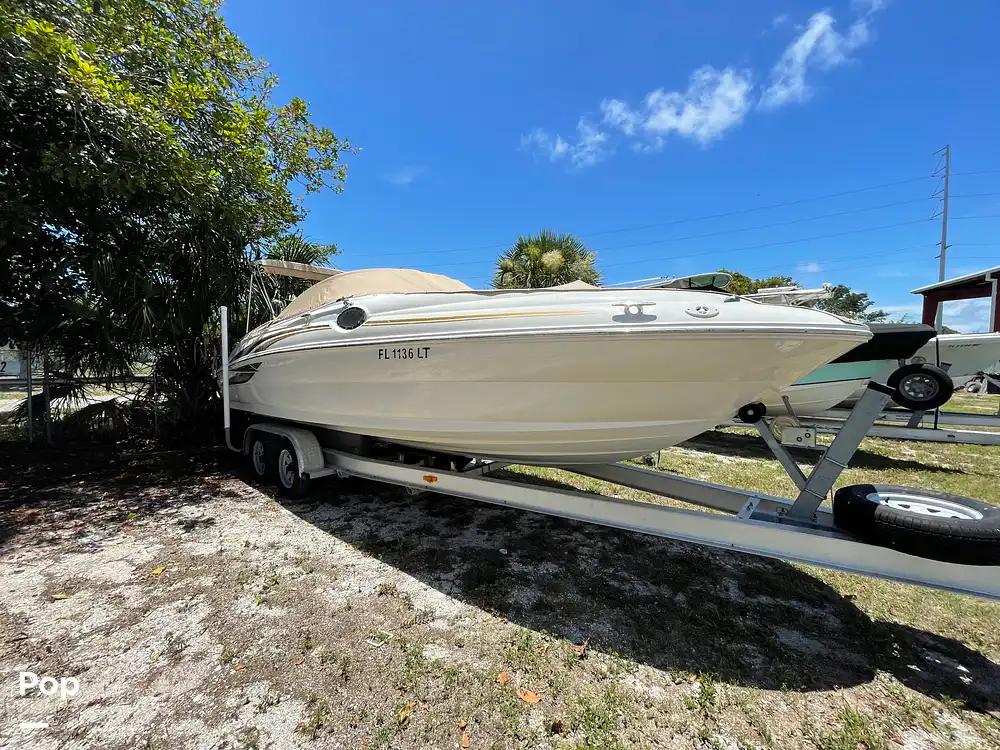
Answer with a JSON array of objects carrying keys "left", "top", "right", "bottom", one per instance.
[{"left": 224, "top": 0, "right": 1000, "bottom": 330}]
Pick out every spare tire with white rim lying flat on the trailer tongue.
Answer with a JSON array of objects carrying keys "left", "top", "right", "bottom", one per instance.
[{"left": 833, "top": 484, "right": 1000, "bottom": 565}]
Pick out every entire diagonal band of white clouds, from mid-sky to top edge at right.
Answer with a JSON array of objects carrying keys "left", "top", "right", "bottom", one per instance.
[{"left": 521, "top": 0, "right": 883, "bottom": 168}]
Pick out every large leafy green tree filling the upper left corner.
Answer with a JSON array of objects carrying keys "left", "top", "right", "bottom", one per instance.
[{"left": 0, "top": 0, "right": 350, "bottom": 438}]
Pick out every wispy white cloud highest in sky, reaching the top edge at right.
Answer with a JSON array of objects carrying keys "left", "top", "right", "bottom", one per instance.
[{"left": 760, "top": 0, "right": 882, "bottom": 109}]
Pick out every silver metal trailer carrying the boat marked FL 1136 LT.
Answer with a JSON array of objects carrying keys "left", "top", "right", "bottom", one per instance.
[{"left": 221, "top": 308, "right": 1000, "bottom": 600}]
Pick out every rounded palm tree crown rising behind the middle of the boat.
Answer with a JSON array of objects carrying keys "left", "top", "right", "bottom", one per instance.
[{"left": 493, "top": 229, "right": 601, "bottom": 289}]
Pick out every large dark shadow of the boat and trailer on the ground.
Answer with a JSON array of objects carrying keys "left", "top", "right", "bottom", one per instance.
[{"left": 287, "top": 480, "right": 1000, "bottom": 712}]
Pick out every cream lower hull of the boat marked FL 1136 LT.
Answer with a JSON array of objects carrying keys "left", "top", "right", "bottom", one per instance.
[{"left": 231, "top": 333, "right": 868, "bottom": 464}]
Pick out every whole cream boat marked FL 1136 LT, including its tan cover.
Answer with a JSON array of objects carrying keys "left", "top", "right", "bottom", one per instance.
[{"left": 229, "top": 269, "right": 872, "bottom": 465}]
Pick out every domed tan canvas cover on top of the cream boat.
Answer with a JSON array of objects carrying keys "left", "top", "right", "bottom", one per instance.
[{"left": 278, "top": 268, "right": 472, "bottom": 319}]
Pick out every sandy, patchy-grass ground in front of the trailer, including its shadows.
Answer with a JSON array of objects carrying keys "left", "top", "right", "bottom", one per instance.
[{"left": 0, "top": 446, "right": 1000, "bottom": 750}]
